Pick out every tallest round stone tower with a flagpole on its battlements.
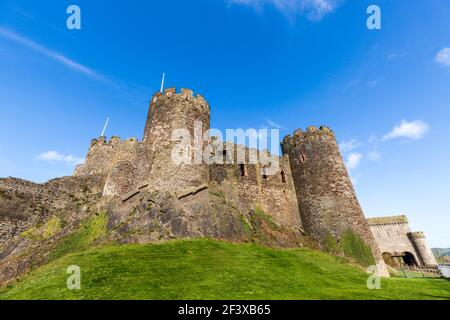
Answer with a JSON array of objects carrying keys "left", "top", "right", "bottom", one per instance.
[{"left": 143, "top": 88, "right": 210, "bottom": 191}]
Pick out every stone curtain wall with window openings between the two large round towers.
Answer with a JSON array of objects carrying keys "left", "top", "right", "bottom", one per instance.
[{"left": 210, "top": 143, "right": 302, "bottom": 231}]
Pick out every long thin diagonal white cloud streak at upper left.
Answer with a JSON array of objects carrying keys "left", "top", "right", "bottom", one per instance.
[{"left": 0, "top": 27, "right": 109, "bottom": 82}]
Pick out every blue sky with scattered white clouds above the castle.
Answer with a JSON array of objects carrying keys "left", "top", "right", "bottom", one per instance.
[{"left": 0, "top": 0, "right": 450, "bottom": 247}]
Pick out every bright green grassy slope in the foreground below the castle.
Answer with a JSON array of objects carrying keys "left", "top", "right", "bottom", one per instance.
[{"left": 0, "top": 239, "right": 450, "bottom": 299}]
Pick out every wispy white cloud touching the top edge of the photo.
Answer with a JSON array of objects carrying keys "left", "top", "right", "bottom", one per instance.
[{"left": 226, "top": 0, "right": 339, "bottom": 21}]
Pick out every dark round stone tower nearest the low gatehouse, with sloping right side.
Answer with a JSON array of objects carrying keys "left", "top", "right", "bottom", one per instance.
[{"left": 282, "top": 127, "right": 388, "bottom": 276}]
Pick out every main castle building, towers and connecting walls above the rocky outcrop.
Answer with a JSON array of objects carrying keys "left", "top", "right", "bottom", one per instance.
[{"left": 75, "top": 88, "right": 387, "bottom": 275}]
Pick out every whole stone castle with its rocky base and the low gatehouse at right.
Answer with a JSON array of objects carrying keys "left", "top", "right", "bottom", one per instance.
[{"left": 0, "top": 88, "right": 436, "bottom": 283}]
